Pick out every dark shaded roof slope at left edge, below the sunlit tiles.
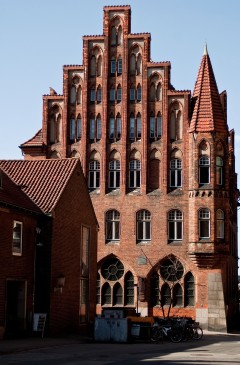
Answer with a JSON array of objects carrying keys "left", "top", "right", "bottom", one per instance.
[{"left": 0, "top": 169, "right": 42, "bottom": 213}]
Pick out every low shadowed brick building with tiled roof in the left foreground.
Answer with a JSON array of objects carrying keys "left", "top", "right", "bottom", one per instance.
[{"left": 0, "top": 159, "right": 98, "bottom": 336}]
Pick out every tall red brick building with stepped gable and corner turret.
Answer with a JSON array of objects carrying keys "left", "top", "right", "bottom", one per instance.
[{"left": 20, "top": 6, "right": 237, "bottom": 330}]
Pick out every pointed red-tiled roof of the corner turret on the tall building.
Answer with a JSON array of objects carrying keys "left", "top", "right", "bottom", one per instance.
[{"left": 189, "top": 45, "right": 227, "bottom": 132}]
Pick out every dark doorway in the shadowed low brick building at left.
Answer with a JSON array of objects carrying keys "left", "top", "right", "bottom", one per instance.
[{"left": 6, "top": 280, "right": 27, "bottom": 336}]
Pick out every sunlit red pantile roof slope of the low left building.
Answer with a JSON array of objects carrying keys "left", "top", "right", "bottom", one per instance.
[{"left": 0, "top": 158, "right": 79, "bottom": 213}]
